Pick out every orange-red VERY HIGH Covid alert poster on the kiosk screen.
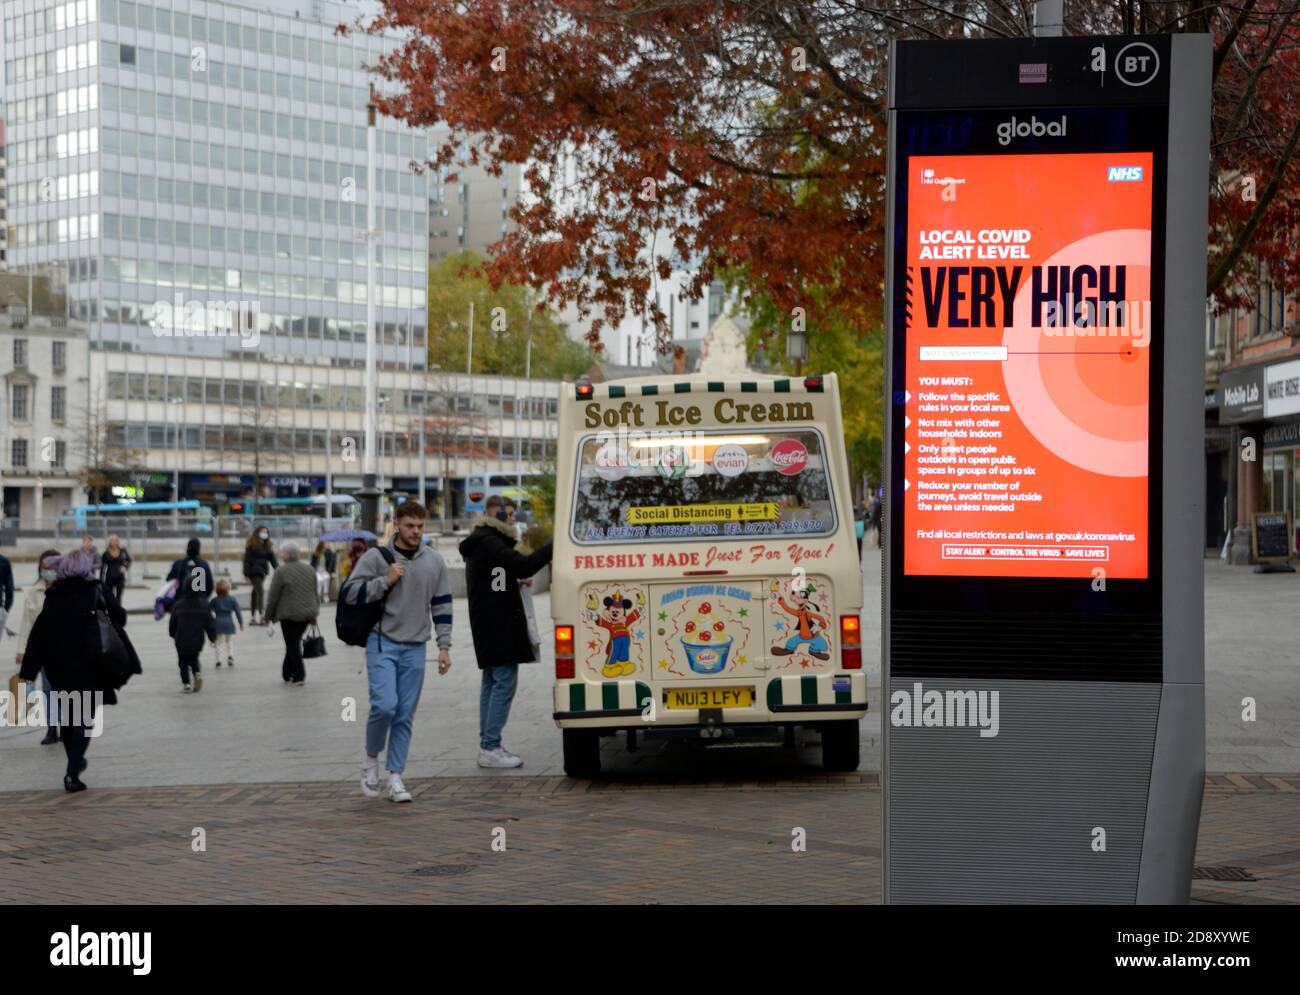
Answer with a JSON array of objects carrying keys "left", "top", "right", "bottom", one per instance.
[{"left": 904, "top": 152, "right": 1156, "bottom": 579}]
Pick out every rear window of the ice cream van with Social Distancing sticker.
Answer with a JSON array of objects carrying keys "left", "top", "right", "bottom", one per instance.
[{"left": 572, "top": 429, "right": 836, "bottom": 544}]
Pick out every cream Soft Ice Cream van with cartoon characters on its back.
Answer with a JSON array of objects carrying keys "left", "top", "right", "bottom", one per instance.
[{"left": 551, "top": 375, "right": 867, "bottom": 778}]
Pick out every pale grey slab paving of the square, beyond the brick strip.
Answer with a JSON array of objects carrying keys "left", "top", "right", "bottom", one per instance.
[{"left": 0, "top": 549, "right": 1300, "bottom": 791}]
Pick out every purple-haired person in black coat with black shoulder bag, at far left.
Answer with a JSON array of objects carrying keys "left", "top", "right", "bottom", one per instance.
[{"left": 20, "top": 549, "right": 140, "bottom": 792}]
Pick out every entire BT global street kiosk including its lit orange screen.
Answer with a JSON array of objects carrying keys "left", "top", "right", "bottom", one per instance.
[{"left": 883, "top": 35, "right": 1206, "bottom": 903}]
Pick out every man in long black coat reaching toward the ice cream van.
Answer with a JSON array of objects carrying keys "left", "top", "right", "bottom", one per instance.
[{"left": 460, "top": 494, "right": 551, "bottom": 767}]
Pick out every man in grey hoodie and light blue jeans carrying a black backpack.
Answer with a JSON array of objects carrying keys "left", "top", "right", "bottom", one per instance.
[{"left": 339, "top": 501, "right": 451, "bottom": 801}]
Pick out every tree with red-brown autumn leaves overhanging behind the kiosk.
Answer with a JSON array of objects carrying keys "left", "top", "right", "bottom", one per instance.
[{"left": 363, "top": 0, "right": 1300, "bottom": 346}]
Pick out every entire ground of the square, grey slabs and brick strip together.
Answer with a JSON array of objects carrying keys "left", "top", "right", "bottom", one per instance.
[{"left": 0, "top": 550, "right": 1300, "bottom": 904}]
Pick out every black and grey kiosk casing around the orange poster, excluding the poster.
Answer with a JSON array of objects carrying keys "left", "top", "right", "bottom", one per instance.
[{"left": 881, "top": 35, "right": 1210, "bottom": 904}]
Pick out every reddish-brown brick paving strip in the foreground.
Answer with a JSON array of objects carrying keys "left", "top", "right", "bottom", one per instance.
[{"left": 0, "top": 773, "right": 1300, "bottom": 904}]
